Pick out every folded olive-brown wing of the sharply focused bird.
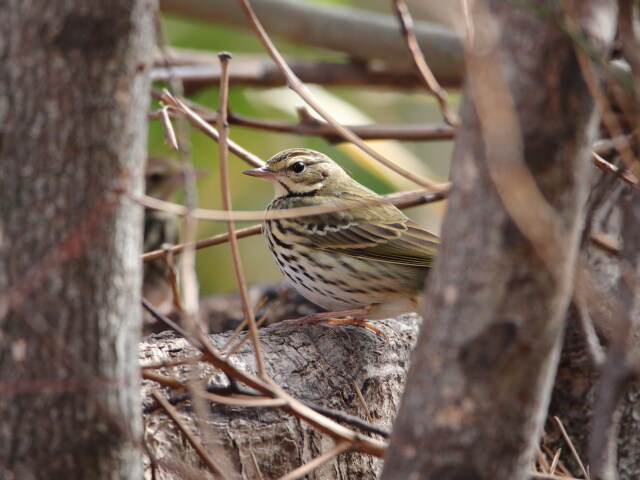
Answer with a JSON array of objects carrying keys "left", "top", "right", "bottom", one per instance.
[{"left": 295, "top": 197, "right": 440, "bottom": 267}]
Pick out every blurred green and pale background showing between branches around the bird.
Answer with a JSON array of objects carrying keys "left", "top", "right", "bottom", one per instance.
[{"left": 149, "top": 1, "right": 459, "bottom": 296}]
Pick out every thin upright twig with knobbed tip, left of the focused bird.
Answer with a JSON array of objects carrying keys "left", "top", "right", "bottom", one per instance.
[{"left": 218, "top": 52, "right": 267, "bottom": 378}]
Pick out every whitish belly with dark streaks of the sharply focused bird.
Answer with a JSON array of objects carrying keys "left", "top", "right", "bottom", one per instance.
[{"left": 272, "top": 242, "right": 421, "bottom": 319}]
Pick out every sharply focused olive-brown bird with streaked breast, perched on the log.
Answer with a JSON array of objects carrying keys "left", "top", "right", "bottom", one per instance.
[{"left": 243, "top": 148, "right": 440, "bottom": 334}]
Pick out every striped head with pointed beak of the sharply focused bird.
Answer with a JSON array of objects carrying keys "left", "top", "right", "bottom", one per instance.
[{"left": 243, "top": 148, "right": 355, "bottom": 198}]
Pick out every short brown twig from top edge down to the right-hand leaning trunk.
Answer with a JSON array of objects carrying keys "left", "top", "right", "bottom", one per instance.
[{"left": 393, "top": 0, "right": 460, "bottom": 127}]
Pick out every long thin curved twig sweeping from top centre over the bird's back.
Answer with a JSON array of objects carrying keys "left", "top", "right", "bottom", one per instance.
[{"left": 238, "top": 0, "right": 434, "bottom": 191}]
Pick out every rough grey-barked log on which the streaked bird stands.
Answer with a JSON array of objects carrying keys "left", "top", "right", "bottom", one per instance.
[{"left": 140, "top": 315, "right": 419, "bottom": 480}]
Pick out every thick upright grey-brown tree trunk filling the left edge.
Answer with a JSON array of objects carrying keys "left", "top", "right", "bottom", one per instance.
[{"left": 0, "top": 0, "right": 152, "bottom": 480}]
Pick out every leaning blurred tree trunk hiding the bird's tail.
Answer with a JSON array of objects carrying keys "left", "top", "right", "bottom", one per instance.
[{"left": 382, "top": 1, "right": 615, "bottom": 480}]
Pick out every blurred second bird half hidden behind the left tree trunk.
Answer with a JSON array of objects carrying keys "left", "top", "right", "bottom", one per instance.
[{"left": 142, "top": 157, "right": 184, "bottom": 314}]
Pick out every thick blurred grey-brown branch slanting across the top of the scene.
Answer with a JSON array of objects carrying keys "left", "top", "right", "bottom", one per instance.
[{"left": 160, "top": 0, "right": 463, "bottom": 86}]
